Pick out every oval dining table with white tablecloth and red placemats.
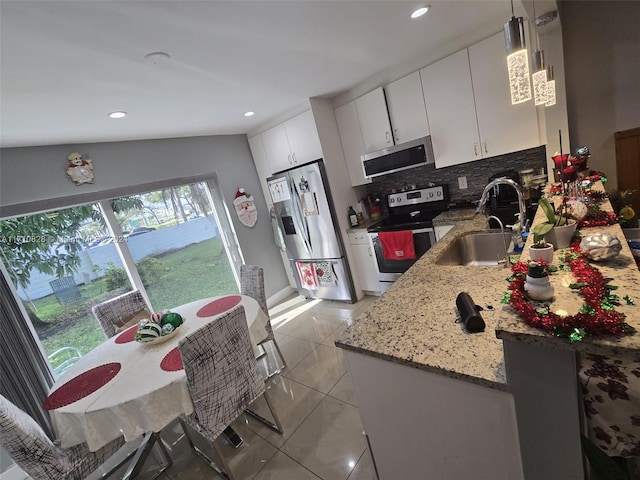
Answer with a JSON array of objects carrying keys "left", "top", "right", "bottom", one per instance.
[{"left": 43, "top": 295, "right": 268, "bottom": 451}]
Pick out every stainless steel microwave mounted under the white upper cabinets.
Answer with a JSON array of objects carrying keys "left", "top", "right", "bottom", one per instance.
[{"left": 360, "top": 137, "right": 435, "bottom": 178}]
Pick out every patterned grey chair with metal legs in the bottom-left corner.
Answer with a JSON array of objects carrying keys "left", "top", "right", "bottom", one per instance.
[{"left": 0, "top": 395, "right": 173, "bottom": 480}]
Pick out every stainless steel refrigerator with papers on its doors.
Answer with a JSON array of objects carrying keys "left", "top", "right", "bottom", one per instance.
[{"left": 267, "top": 160, "right": 356, "bottom": 303}]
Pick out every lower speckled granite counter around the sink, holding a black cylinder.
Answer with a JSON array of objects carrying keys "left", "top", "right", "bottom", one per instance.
[{"left": 336, "top": 214, "right": 509, "bottom": 390}]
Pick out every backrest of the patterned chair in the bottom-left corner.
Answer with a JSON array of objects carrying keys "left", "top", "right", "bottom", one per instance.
[{"left": 0, "top": 395, "right": 67, "bottom": 480}]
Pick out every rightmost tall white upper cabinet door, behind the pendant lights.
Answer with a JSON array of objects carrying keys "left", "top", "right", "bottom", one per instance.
[{"left": 469, "top": 33, "right": 540, "bottom": 158}]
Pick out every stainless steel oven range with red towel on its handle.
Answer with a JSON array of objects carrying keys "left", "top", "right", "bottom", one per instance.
[{"left": 367, "top": 185, "right": 449, "bottom": 292}]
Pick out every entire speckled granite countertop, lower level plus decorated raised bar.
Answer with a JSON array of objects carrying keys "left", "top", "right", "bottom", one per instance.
[{"left": 335, "top": 187, "right": 640, "bottom": 390}]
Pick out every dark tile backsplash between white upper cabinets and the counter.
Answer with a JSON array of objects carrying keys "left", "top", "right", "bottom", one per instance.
[{"left": 365, "top": 145, "right": 547, "bottom": 206}]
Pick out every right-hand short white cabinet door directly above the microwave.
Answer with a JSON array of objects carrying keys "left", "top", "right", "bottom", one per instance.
[{"left": 384, "top": 72, "right": 429, "bottom": 144}]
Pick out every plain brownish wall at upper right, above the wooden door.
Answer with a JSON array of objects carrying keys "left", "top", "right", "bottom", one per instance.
[{"left": 558, "top": 0, "right": 640, "bottom": 189}]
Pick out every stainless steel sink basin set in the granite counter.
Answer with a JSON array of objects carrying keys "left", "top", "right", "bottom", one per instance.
[{"left": 436, "top": 231, "right": 513, "bottom": 267}]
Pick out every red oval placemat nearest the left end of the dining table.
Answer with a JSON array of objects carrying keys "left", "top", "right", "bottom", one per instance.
[{"left": 42, "top": 362, "right": 122, "bottom": 410}]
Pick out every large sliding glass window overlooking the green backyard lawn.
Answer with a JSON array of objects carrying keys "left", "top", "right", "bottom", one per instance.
[{"left": 0, "top": 178, "right": 242, "bottom": 374}]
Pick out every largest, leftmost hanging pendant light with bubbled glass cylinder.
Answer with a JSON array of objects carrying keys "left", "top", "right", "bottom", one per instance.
[{"left": 504, "top": 0, "right": 531, "bottom": 105}]
